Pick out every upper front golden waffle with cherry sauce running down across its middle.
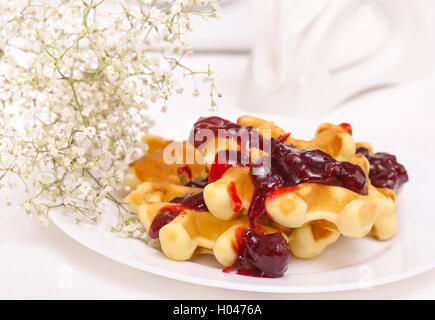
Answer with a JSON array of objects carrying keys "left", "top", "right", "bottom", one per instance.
[{"left": 204, "top": 155, "right": 395, "bottom": 238}]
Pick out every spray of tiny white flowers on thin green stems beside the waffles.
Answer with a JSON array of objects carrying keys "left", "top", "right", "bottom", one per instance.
[{"left": 0, "top": 0, "right": 219, "bottom": 230}]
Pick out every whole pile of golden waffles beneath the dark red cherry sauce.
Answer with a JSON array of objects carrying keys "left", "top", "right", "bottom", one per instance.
[{"left": 124, "top": 116, "right": 408, "bottom": 278}]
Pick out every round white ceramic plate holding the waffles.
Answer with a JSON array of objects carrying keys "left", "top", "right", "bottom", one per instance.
[{"left": 51, "top": 117, "right": 435, "bottom": 293}]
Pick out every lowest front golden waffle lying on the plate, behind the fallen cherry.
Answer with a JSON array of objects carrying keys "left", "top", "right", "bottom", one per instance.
[{"left": 138, "top": 201, "right": 339, "bottom": 266}]
